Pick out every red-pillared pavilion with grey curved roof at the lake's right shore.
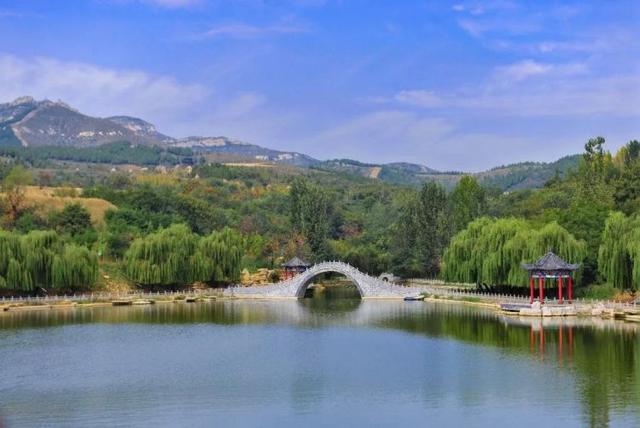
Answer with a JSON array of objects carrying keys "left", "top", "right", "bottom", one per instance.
[{"left": 522, "top": 251, "right": 580, "bottom": 304}]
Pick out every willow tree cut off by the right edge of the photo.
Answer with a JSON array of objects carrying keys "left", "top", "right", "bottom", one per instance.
[{"left": 598, "top": 212, "right": 640, "bottom": 289}]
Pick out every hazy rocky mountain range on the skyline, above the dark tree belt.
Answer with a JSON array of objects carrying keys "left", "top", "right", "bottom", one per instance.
[{"left": 0, "top": 97, "right": 580, "bottom": 191}]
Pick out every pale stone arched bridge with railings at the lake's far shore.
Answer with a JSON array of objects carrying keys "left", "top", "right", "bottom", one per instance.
[{"left": 225, "top": 262, "right": 427, "bottom": 298}]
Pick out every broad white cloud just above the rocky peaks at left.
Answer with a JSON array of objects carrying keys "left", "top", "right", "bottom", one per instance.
[{"left": 0, "top": 54, "right": 209, "bottom": 125}]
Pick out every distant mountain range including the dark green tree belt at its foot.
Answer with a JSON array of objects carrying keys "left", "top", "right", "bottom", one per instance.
[{"left": 0, "top": 97, "right": 580, "bottom": 191}]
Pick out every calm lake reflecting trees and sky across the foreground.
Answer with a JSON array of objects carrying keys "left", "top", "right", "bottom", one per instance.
[{"left": 0, "top": 293, "right": 640, "bottom": 427}]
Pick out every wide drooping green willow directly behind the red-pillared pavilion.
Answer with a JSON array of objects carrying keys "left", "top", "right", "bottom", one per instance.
[{"left": 443, "top": 218, "right": 586, "bottom": 286}]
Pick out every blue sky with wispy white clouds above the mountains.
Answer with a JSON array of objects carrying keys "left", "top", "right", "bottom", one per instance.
[{"left": 0, "top": 0, "right": 640, "bottom": 171}]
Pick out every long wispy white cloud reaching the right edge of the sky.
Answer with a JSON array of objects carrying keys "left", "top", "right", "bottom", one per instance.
[{"left": 380, "top": 60, "right": 640, "bottom": 118}]
